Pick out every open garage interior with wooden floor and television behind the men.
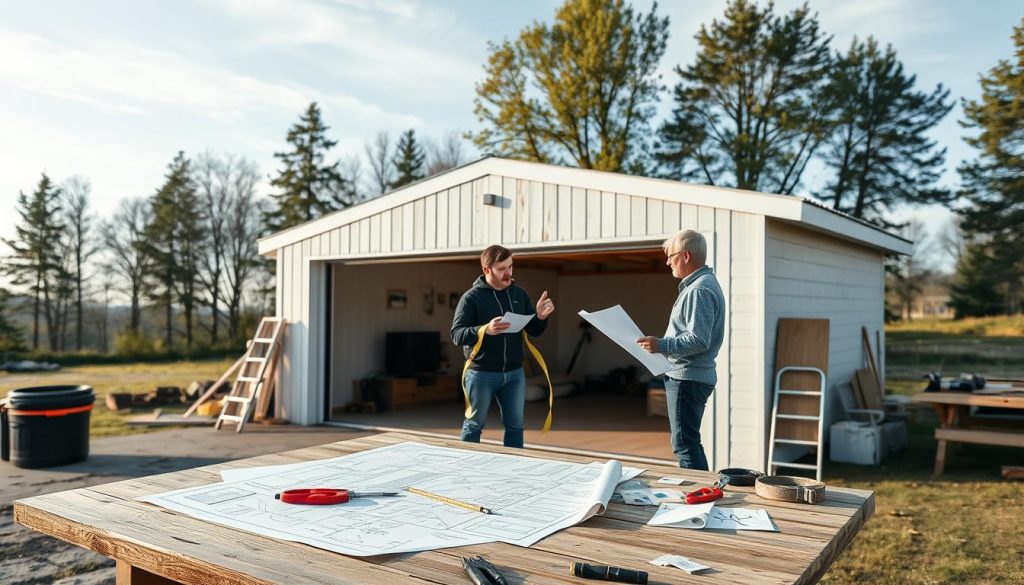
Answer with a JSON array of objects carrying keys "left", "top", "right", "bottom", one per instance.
[{"left": 325, "top": 244, "right": 679, "bottom": 461}]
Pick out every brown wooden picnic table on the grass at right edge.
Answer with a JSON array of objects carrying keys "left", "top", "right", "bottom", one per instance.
[{"left": 912, "top": 392, "right": 1024, "bottom": 475}]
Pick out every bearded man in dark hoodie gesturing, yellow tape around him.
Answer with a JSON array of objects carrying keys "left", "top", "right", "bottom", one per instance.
[{"left": 452, "top": 246, "right": 555, "bottom": 449}]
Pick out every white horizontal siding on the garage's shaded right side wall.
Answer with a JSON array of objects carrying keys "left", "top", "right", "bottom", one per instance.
[{"left": 764, "top": 220, "right": 885, "bottom": 448}]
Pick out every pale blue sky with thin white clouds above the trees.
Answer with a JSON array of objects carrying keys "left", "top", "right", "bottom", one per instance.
[{"left": 0, "top": 0, "right": 1024, "bottom": 274}]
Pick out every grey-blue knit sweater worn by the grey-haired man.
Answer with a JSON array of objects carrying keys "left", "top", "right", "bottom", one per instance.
[{"left": 657, "top": 266, "right": 725, "bottom": 386}]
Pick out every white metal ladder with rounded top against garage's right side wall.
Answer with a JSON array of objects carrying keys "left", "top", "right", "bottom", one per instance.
[{"left": 768, "top": 366, "right": 825, "bottom": 482}]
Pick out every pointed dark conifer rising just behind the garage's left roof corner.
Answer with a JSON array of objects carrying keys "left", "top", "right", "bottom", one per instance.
[{"left": 265, "top": 101, "right": 356, "bottom": 231}]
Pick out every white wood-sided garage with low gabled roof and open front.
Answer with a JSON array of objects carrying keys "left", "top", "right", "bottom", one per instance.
[{"left": 259, "top": 157, "right": 910, "bottom": 468}]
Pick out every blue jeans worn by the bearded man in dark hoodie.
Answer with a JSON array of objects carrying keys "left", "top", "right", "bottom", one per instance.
[{"left": 462, "top": 368, "right": 526, "bottom": 449}]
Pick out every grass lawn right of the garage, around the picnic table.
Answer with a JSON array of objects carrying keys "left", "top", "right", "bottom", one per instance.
[{"left": 822, "top": 318, "right": 1024, "bottom": 585}]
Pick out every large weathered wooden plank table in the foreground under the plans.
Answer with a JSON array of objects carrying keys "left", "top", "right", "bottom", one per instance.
[{"left": 14, "top": 433, "right": 874, "bottom": 584}]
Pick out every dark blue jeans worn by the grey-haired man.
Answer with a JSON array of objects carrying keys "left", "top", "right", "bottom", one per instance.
[{"left": 665, "top": 376, "right": 715, "bottom": 471}]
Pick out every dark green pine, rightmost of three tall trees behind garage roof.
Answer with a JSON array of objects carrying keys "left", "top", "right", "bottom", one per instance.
[{"left": 818, "top": 37, "right": 952, "bottom": 227}]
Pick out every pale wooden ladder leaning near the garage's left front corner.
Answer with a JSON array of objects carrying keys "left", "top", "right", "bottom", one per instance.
[{"left": 213, "top": 317, "right": 285, "bottom": 432}]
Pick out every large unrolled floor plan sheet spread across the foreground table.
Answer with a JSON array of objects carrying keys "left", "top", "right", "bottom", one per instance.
[{"left": 139, "top": 443, "right": 642, "bottom": 556}]
